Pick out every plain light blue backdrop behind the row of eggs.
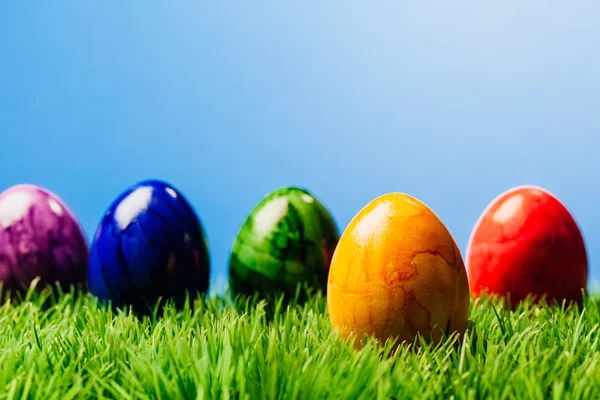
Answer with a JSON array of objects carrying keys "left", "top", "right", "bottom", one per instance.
[{"left": 0, "top": 0, "right": 600, "bottom": 289}]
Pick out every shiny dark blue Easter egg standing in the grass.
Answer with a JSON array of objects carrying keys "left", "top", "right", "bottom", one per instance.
[{"left": 88, "top": 180, "right": 209, "bottom": 313}]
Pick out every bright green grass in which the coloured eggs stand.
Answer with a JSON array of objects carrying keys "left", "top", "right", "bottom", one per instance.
[{"left": 0, "top": 282, "right": 600, "bottom": 400}]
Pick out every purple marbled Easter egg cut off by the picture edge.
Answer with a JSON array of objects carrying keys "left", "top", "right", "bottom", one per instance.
[{"left": 0, "top": 185, "right": 88, "bottom": 291}]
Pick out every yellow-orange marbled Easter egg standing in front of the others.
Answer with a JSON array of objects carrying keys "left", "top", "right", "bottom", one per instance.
[{"left": 327, "top": 193, "right": 470, "bottom": 347}]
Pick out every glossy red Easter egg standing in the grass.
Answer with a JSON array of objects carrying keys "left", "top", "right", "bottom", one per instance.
[{"left": 466, "top": 186, "right": 588, "bottom": 307}]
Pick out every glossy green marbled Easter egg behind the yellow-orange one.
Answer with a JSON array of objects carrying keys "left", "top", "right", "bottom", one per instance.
[{"left": 229, "top": 187, "right": 339, "bottom": 296}]
